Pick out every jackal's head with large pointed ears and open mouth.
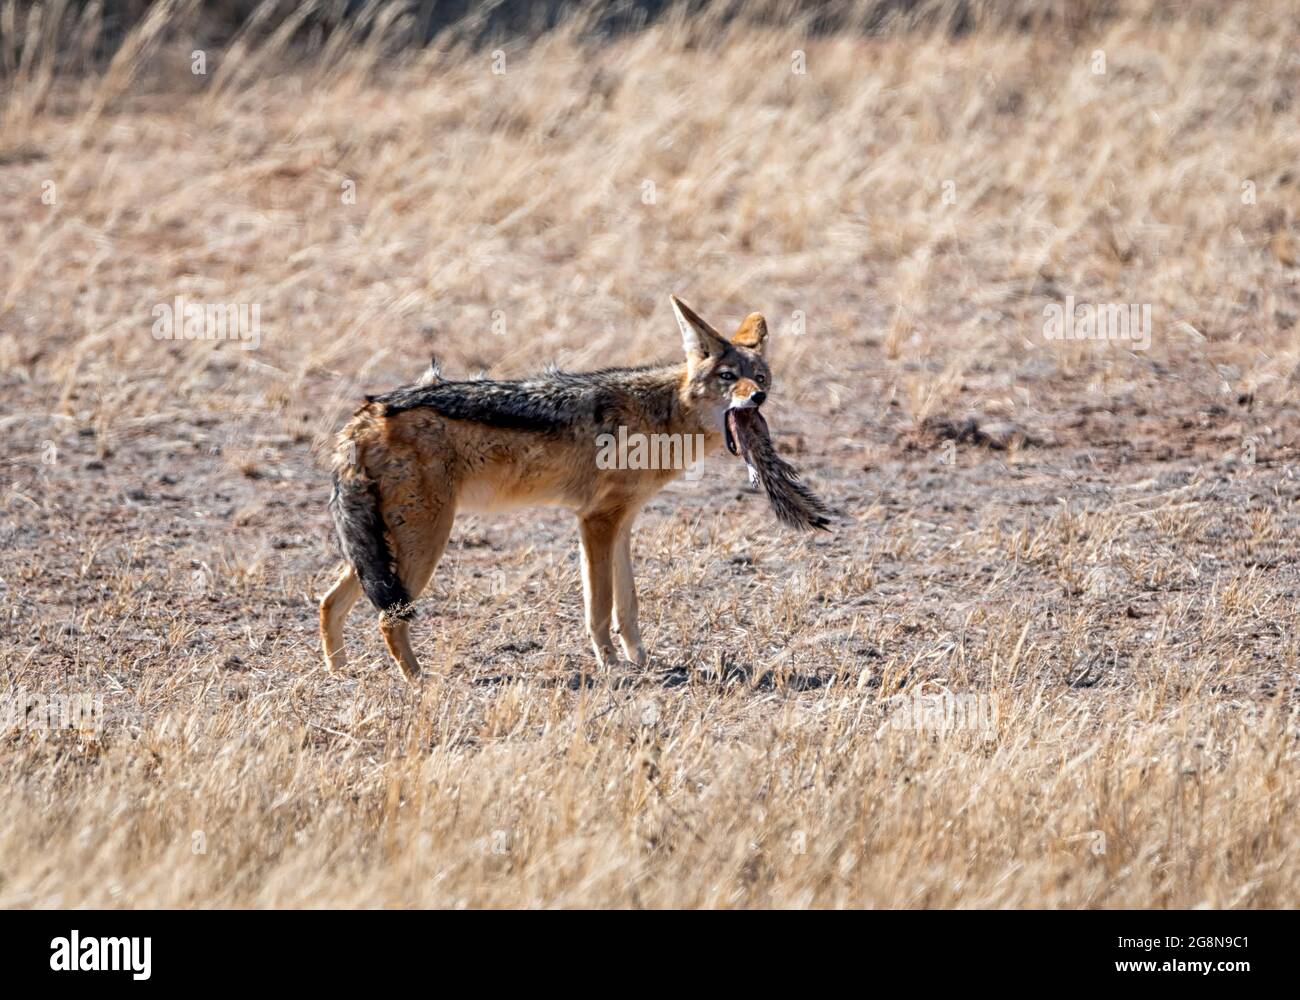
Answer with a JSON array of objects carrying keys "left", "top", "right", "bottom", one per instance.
[{"left": 671, "top": 295, "right": 772, "bottom": 455}]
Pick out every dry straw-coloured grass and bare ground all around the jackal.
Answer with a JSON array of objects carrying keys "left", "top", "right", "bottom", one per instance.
[{"left": 0, "top": 0, "right": 1300, "bottom": 906}]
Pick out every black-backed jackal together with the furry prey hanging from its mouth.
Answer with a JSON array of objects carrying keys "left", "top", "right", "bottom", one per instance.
[{"left": 320, "top": 296, "right": 828, "bottom": 680}]
